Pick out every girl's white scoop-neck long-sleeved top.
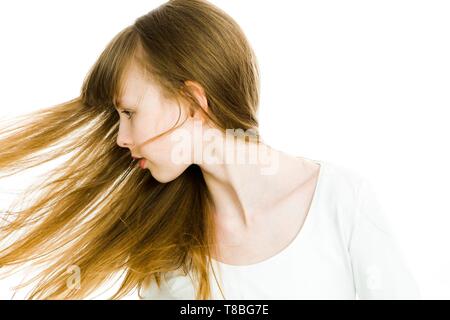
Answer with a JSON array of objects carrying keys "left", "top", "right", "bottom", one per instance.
[{"left": 141, "top": 160, "right": 420, "bottom": 300}]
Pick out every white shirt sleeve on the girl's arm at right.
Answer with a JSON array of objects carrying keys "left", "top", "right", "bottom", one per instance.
[{"left": 349, "top": 177, "right": 421, "bottom": 300}]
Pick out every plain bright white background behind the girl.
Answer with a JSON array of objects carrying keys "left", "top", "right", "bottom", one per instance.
[{"left": 0, "top": 0, "right": 450, "bottom": 299}]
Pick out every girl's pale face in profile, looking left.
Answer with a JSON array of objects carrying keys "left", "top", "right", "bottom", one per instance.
[{"left": 117, "top": 63, "right": 199, "bottom": 183}]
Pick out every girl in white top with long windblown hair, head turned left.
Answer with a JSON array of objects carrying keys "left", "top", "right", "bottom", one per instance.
[{"left": 0, "top": 0, "right": 418, "bottom": 299}]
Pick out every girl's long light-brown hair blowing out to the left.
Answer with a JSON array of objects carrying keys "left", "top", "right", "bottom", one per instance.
[{"left": 0, "top": 0, "right": 259, "bottom": 299}]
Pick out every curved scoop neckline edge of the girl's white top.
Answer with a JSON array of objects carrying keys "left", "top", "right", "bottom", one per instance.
[{"left": 211, "top": 159, "right": 325, "bottom": 269}]
